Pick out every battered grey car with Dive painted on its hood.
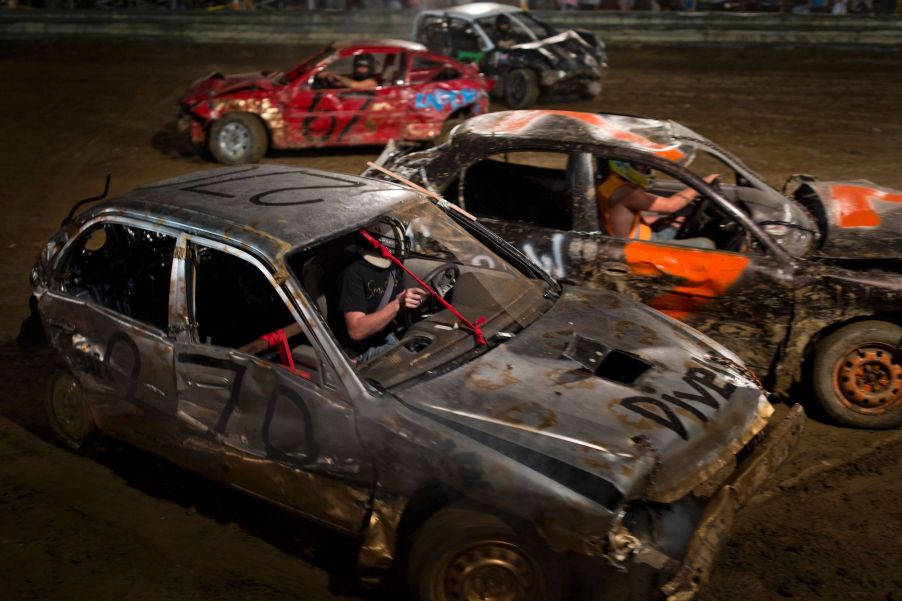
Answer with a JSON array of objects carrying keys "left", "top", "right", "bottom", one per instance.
[{"left": 32, "top": 166, "right": 804, "bottom": 601}]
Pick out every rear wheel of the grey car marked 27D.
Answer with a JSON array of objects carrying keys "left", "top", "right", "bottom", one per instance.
[{"left": 44, "top": 369, "right": 99, "bottom": 451}]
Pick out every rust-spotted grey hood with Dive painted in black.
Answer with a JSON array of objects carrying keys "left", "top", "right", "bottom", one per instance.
[{"left": 393, "top": 288, "right": 773, "bottom": 502}]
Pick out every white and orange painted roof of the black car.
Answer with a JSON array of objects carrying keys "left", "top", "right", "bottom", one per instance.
[{"left": 452, "top": 110, "right": 704, "bottom": 162}]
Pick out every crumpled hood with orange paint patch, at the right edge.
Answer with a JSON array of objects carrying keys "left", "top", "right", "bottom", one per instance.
[{"left": 794, "top": 180, "right": 902, "bottom": 259}]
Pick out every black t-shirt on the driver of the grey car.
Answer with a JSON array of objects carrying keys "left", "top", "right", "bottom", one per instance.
[{"left": 338, "top": 259, "right": 402, "bottom": 355}]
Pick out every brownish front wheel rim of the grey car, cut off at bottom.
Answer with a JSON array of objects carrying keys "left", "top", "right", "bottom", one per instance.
[{"left": 437, "top": 541, "right": 541, "bottom": 601}]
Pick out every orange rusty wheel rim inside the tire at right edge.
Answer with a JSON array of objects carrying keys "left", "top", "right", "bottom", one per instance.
[{"left": 834, "top": 342, "right": 902, "bottom": 414}]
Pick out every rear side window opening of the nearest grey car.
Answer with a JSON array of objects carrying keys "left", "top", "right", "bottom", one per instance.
[{"left": 60, "top": 222, "right": 176, "bottom": 332}]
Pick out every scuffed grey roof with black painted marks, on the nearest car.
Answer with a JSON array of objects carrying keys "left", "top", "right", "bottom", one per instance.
[{"left": 79, "top": 165, "right": 422, "bottom": 261}]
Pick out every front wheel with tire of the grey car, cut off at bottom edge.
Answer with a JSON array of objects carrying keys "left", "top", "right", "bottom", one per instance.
[{"left": 407, "top": 507, "right": 560, "bottom": 601}]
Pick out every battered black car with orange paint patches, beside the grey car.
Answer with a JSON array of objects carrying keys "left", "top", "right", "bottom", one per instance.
[{"left": 370, "top": 110, "right": 902, "bottom": 428}]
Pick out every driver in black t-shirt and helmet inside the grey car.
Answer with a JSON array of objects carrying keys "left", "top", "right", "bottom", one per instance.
[{"left": 338, "top": 224, "right": 426, "bottom": 363}]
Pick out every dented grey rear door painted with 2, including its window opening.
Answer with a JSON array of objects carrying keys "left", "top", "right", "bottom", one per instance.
[{"left": 39, "top": 219, "right": 176, "bottom": 446}]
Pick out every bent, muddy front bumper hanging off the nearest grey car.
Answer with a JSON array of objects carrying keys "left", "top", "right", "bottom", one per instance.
[{"left": 661, "top": 405, "right": 805, "bottom": 601}]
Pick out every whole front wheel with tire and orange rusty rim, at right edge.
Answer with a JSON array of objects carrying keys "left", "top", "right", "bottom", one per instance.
[{"left": 811, "top": 321, "right": 902, "bottom": 429}]
